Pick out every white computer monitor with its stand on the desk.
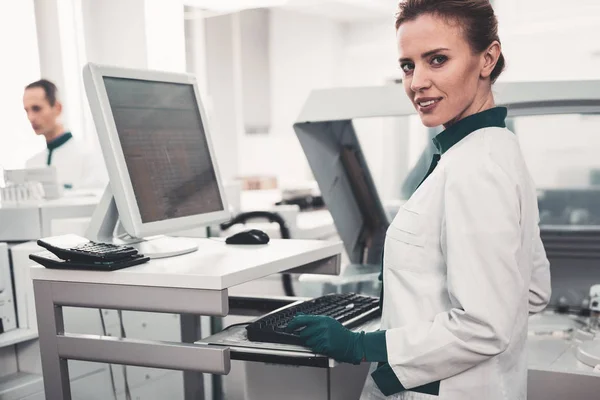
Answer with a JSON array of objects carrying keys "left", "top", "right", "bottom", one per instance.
[{"left": 83, "top": 63, "right": 229, "bottom": 258}]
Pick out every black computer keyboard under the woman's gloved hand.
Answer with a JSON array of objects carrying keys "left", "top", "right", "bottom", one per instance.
[{"left": 246, "top": 293, "right": 381, "bottom": 345}]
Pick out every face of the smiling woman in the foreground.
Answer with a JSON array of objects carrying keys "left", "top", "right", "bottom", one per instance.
[{"left": 397, "top": 14, "right": 493, "bottom": 127}]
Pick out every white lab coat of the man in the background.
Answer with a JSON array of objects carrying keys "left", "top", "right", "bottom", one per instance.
[{"left": 26, "top": 137, "right": 108, "bottom": 189}]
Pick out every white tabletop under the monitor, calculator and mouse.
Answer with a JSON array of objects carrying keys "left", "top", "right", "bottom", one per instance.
[{"left": 31, "top": 238, "right": 343, "bottom": 290}]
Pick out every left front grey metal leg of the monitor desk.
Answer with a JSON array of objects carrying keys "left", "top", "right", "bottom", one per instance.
[{"left": 33, "top": 281, "right": 71, "bottom": 400}]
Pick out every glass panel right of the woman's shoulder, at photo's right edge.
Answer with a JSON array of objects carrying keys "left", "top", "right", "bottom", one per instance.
[{"left": 508, "top": 114, "right": 600, "bottom": 226}]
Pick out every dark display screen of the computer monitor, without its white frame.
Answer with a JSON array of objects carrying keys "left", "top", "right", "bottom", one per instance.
[{"left": 103, "top": 77, "right": 223, "bottom": 223}]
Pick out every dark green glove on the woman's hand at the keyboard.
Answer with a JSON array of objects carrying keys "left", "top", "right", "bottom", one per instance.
[{"left": 287, "top": 314, "right": 365, "bottom": 364}]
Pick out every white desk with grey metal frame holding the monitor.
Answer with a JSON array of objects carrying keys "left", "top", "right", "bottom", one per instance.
[{"left": 31, "top": 239, "right": 342, "bottom": 399}]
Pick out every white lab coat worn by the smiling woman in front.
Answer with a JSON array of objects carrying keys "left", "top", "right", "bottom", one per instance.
[{"left": 361, "top": 128, "right": 550, "bottom": 400}]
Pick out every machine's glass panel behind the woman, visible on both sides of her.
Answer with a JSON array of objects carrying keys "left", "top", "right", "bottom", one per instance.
[{"left": 353, "top": 114, "right": 600, "bottom": 226}]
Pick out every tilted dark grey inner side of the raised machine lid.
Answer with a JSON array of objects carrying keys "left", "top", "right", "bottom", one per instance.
[{"left": 294, "top": 92, "right": 389, "bottom": 265}]
